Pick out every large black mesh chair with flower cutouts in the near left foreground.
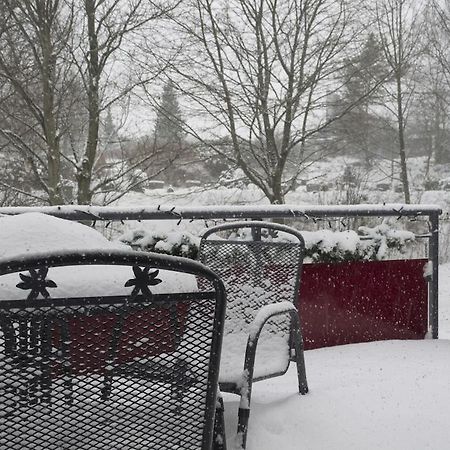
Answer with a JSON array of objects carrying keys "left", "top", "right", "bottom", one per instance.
[{"left": 0, "top": 250, "right": 226, "bottom": 450}]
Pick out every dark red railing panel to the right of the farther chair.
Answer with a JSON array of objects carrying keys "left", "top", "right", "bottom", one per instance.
[{"left": 300, "top": 259, "right": 428, "bottom": 350}]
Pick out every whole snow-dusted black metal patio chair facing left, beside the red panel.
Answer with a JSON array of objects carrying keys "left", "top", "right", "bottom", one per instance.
[{"left": 199, "top": 221, "right": 308, "bottom": 448}]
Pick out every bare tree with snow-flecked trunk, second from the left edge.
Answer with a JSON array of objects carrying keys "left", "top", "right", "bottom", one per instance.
[{"left": 71, "top": 0, "right": 179, "bottom": 204}]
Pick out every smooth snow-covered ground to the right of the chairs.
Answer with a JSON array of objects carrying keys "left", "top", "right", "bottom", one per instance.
[{"left": 224, "top": 264, "right": 450, "bottom": 450}]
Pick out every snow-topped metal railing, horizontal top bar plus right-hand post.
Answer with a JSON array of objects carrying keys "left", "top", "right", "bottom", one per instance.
[{"left": 0, "top": 204, "right": 442, "bottom": 339}]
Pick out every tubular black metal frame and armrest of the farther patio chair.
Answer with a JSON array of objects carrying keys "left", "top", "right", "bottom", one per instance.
[{"left": 199, "top": 221, "right": 308, "bottom": 448}]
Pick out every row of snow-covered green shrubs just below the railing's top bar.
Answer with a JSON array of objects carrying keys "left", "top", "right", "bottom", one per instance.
[{"left": 119, "top": 222, "right": 415, "bottom": 262}]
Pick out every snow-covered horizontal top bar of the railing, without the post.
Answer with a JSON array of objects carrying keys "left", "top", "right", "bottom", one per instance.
[{"left": 0, "top": 203, "right": 442, "bottom": 220}]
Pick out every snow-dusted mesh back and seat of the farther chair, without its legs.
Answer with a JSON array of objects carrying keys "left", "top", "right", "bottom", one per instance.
[{"left": 199, "top": 222, "right": 304, "bottom": 381}]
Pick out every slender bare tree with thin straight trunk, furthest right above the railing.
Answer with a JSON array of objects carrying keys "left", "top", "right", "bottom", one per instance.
[{"left": 374, "top": 0, "right": 423, "bottom": 203}]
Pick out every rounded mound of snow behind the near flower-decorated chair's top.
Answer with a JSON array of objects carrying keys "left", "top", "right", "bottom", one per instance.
[{"left": 0, "top": 213, "right": 198, "bottom": 300}]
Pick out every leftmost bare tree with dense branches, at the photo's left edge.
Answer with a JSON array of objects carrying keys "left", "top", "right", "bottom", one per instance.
[{"left": 0, "top": 0, "right": 72, "bottom": 204}]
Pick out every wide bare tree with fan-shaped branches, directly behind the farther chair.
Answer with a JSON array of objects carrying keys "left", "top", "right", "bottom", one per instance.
[{"left": 158, "top": 0, "right": 357, "bottom": 204}]
